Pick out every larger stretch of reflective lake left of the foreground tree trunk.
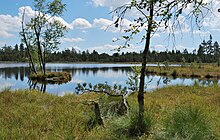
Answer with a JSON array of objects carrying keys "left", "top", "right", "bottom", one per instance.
[{"left": 0, "top": 64, "right": 131, "bottom": 95}]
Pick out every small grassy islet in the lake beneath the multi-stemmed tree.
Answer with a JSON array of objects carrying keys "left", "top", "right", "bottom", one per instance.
[{"left": 29, "top": 72, "right": 71, "bottom": 83}]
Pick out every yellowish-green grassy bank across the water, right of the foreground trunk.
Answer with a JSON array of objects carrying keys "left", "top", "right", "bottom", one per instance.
[{"left": 147, "top": 63, "right": 220, "bottom": 79}]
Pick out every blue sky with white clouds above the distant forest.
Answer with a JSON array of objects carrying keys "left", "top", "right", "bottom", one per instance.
[{"left": 0, "top": 0, "right": 220, "bottom": 54}]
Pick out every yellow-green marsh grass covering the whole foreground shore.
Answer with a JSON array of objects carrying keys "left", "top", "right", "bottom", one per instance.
[{"left": 0, "top": 85, "right": 220, "bottom": 140}]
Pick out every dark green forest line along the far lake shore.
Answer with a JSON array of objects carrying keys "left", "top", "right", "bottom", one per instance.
[{"left": 0, "top": 40, "right": 220, "bottom": 63}]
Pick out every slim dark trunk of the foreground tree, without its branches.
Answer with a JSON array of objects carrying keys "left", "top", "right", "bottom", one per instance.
[{"left": 138, "top": 2, "right": 154, "bottom": 133}]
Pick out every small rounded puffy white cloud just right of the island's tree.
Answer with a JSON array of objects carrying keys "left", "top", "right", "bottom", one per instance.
[{"left": 70, "top": 18, "right": 92, "bottom": 29}]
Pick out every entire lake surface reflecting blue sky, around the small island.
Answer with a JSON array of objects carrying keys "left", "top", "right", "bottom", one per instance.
[{"left": 0, "top": 63, "right": 217, "bottom": 96}]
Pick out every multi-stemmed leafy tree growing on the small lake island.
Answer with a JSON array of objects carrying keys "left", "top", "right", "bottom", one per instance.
[{"left": 20, "top": 0, "right": 67, "bottom": 75}]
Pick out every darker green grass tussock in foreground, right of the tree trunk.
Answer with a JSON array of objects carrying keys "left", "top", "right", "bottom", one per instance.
[{"left": 162, "top": 106, "right": 215, "bottom": 140}]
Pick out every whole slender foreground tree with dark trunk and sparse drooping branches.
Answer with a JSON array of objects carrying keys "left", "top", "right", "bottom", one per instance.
[{"left": 112, "top": 0, "right": 212, "bottom": 134}]
